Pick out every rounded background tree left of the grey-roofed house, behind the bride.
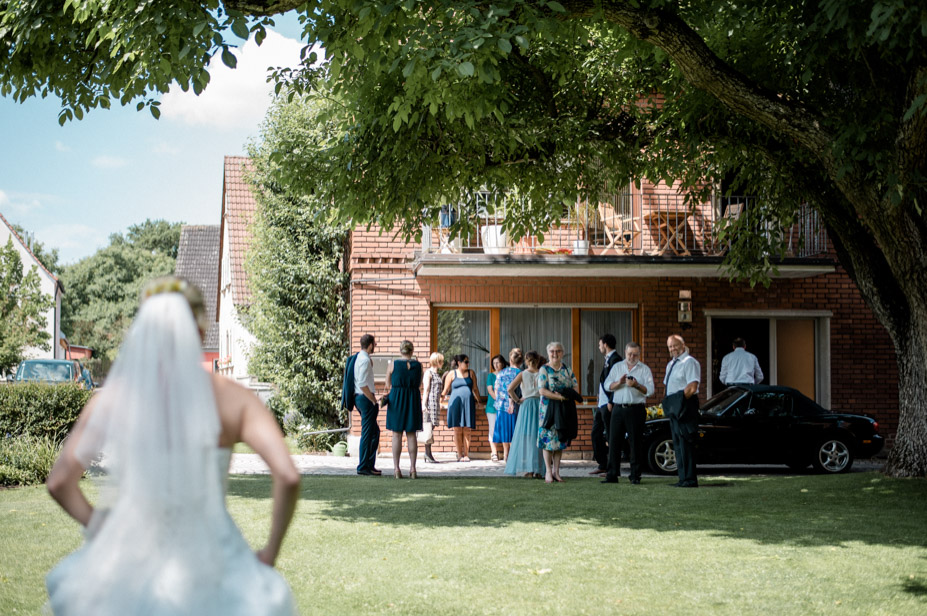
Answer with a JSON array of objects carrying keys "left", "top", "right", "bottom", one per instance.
[{"left": 61, "top": 220, "right": 183, "bottom": 360}]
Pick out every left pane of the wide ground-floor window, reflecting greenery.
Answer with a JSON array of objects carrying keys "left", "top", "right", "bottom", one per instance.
[{"left": 438, "top": 309, "right": 490, "bottom": 396}]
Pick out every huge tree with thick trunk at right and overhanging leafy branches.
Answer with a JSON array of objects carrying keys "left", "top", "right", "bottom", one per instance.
[{"left": 0, "top": 0, "right": 927, "bottom": 476}]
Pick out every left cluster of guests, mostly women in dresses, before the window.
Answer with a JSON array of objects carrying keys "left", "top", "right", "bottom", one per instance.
[{"left": 345, "top": 334, "right": 582, "bottom": 483}]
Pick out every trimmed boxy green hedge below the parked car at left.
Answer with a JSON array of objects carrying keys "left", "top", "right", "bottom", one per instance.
[{"left": 0, "top": 383, "right": 91, "bottom": 442}]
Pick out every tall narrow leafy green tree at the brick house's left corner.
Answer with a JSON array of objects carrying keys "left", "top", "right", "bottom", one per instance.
[{"left": 246, "top": 100, "right": 349, "bottom": 426}]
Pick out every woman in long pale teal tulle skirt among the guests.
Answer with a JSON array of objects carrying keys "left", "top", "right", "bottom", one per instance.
[{"left": 505, "top": 351, "right": 545, "bottom": 479}]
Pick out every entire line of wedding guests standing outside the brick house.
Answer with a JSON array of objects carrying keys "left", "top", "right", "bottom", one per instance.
[{"left": 346, "top": 334, "right": 724, "bottom": 487}]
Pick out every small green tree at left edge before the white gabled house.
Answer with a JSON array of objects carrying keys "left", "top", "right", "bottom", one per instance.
[{"left": 0, "top": 237, "right": 55, "bottom": 372}]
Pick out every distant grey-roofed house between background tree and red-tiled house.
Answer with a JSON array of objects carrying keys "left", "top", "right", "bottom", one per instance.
[{"left": 174, "top": 225, "right": 220, "bottom": 371}]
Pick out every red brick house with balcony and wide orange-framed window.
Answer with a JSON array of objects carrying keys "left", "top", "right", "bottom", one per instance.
[{"left": 348, "top": 181, "right": 898, "bottom": 457}]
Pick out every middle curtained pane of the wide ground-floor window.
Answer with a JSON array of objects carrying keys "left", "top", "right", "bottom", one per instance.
[{"left": 499, "top": 307, "right": 575, "bottom": 370}]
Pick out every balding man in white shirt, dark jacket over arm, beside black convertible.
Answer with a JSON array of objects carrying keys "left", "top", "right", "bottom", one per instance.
[{"left": 663, "top": 334, "right": 702, "bottom": 488}]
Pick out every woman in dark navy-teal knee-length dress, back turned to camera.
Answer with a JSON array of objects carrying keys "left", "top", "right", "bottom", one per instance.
[{"left": 386, "top": 340, "right": 422, "bottom": 479}]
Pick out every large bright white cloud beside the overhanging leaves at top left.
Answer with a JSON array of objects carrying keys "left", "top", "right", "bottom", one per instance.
[{"left": 161, "top": 30, "right": 303, "bottom": 129}]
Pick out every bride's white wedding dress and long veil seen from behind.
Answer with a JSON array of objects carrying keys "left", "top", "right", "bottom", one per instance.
[{"left": 46, "top": 294, "right": 295, "bottom": 616}]
